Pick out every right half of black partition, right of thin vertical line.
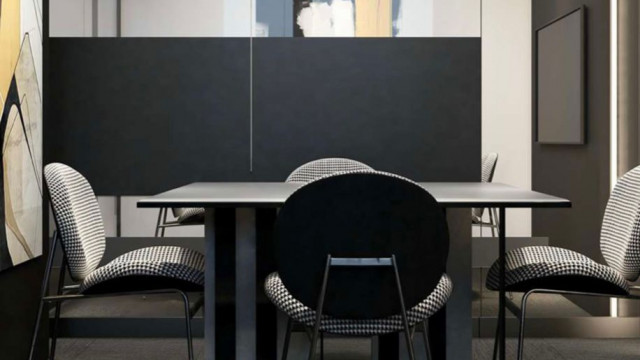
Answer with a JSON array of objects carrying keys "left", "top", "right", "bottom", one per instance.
[{"left": 253, "top": 38, "right": 481, "bottom": 181}]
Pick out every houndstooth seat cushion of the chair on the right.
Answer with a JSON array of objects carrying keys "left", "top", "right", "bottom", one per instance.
[{"left": 487, "top": 246, "right": 629, "bottom": 292}]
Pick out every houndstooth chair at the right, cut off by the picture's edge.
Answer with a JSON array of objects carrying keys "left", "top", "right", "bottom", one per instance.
[{"left": 487, "top": 166, "right": 640, "bottom": 359}]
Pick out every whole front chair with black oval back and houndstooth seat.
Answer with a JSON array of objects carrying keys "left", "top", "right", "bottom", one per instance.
[{"left": 264, "top": 166, "right": 453, "bottom": 360}]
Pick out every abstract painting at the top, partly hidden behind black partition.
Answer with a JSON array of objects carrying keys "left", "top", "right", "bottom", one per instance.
[{"left": 293, "top": 0, "right": 393, "bottom": 37}]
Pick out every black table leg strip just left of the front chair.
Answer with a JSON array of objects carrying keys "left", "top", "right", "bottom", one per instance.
[{"left": 256, "top": 209, "right": 278, "bottom": 360}]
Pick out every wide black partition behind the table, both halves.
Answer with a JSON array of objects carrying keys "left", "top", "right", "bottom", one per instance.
[{"left": 47, "top": 38, "right": 481, "bottom": 195}]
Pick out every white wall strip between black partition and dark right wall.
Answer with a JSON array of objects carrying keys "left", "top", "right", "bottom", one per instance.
[{"left": 482, "top": 0, "right": 531, "bottom": 236}]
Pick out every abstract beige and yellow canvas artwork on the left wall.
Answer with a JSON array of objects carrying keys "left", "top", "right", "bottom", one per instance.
[{"left": 0, "top": 0, "right": 43, "bottom": 270}]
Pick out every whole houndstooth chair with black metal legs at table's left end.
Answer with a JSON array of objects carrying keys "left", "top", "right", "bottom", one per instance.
[{"left": 30, "top": 163, "right": 204, "bottom": 359}]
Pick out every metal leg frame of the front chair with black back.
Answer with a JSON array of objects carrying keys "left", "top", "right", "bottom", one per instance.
[{"left": 282, "top": 254, "right": 431, "bottom": 360}]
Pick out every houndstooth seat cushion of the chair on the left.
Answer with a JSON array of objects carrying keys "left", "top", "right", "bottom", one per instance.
[{"left": 80, "top": 246, "right": 204, "bottom": 294}]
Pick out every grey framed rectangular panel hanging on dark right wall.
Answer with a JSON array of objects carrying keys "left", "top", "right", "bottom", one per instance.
[{"left": 533, "top": 6, "right": 586, "bottom": 145}]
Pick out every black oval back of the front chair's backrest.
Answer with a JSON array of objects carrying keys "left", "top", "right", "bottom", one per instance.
[{"left": 275, "top": 171, "right": 449, "bottom": 319}]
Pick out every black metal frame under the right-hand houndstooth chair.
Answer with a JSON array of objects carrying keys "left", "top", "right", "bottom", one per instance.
[{"left": 493, "top": 286, "right": 640, "bottom": 360}]
